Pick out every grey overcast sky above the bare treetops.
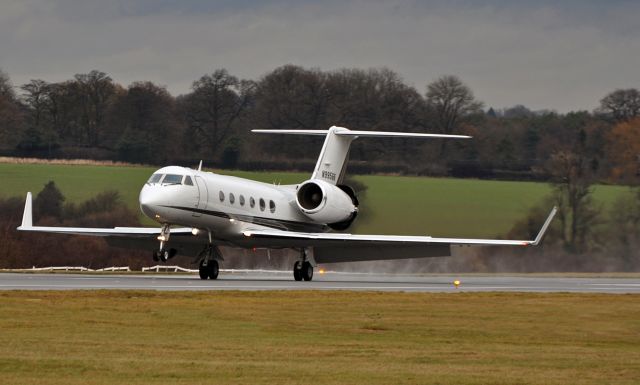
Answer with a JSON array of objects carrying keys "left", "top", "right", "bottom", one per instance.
[{"left": 0, "top": 0, "right": 640, "bottom": 112}]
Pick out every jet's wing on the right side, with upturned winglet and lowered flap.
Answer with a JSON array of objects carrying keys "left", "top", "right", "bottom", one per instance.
[{"left": 243, "top": 207, "right": 557, "bottom": 263}]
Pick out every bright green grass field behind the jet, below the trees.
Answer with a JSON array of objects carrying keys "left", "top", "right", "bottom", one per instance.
[{"left": 0, "top": 163, "right": 628, "bottom": 237}]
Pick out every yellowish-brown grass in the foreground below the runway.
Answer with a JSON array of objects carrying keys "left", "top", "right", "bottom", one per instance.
[{"left": 0, "top": 291, "right": 640, "bottom": 385}]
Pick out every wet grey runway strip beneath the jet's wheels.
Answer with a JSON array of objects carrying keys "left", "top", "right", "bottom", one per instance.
[{"left": 0, "top": 272, "right": 640, "bottom": 294}]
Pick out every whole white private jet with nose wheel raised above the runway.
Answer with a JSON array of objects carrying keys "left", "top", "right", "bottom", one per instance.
[{"left": 18, "top": 126, "right": 556, "bottom": 281}]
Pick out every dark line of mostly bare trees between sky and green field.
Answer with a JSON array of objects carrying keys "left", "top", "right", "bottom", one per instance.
[{"left": 0, "top": 65, "right": 640, "bottom": 181}]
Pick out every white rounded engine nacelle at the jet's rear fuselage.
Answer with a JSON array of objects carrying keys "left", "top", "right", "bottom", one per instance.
[{"left": 296, "top": 179, "right": 358, "bottom": 227}]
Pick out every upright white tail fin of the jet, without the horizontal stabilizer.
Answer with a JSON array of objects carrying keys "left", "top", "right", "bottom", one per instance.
[{"left": 311, "top": 126, "right": 356, "bottom": 185}]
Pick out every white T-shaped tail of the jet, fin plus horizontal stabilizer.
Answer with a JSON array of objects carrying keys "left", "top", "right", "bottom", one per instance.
[{"left": 251, "top": 126, "right": 470, "bottom": 185}]
